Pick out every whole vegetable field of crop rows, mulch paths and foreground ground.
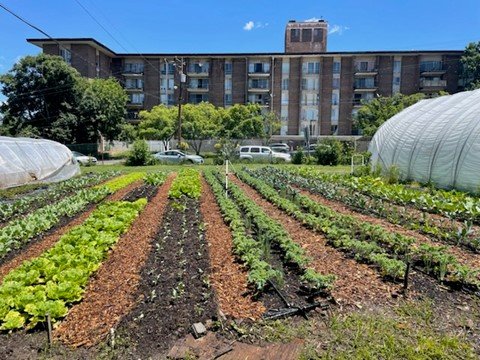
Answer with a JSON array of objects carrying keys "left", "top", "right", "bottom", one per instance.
[{"left": 0, "top": 165, "right": 480, "bottom": 359}]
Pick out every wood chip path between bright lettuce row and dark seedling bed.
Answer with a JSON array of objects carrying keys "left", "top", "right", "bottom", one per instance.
[{"left": 54, "top": 174, "right": 175, "bottom": 347}]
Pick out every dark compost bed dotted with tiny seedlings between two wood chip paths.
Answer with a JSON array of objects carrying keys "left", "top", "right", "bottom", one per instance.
[{"left": 111, "top": 195, "right": 217, "bottom": 359}]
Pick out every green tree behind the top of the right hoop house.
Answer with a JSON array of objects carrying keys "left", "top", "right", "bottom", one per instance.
[{"left": 354, "top": 93, "right": 425, "bottom": 136}]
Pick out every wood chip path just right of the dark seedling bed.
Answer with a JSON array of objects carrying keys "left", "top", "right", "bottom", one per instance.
[{"left": 200, "top": 178, "right": 265, "bottom": 320}]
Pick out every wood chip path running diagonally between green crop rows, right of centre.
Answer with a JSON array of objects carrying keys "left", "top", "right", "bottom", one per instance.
[{"left": 231, "top": 176, "right": 400, "bottom": 307}]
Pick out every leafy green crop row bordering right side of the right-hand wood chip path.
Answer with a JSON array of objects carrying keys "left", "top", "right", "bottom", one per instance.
[{"left": 244, "top": 167, "right": 479, "bottom": 287}]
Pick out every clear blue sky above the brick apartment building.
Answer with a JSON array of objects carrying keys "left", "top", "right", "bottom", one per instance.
[{"left": 0, "top": 0, "right": 480, "bottom": 73}]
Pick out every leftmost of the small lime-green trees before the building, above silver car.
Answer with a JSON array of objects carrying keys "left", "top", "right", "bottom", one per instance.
[{"left": 138, "top": 105, "right": 177, "bottom": 147}]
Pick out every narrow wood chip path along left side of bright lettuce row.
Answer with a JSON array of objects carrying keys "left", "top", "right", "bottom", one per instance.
[{"left": 0, "top": 180, "right": 142, "bottom": 283}]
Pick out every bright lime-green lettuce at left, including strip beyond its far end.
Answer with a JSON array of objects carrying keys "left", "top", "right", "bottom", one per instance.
[{"left": 0, "top": 173, "right": 170, "bottom": 330}]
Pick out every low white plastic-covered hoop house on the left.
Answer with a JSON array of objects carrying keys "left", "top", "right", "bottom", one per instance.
[{"left": 0, "top": 136, "right": 80, "bottom": 188}]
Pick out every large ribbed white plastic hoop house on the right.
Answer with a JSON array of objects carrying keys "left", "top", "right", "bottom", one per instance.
[{"left": 369, "top": 90, "right": 480, "bottom": 192}]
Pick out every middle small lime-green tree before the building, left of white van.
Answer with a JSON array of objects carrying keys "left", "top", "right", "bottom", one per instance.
[{"left": 182, "top": 102, "right": 221, "bottom": 155}]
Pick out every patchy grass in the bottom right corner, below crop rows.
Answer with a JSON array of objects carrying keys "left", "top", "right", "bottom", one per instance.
[{"left": 301, "top": 301, "right": 478, "bottom": 360}]
